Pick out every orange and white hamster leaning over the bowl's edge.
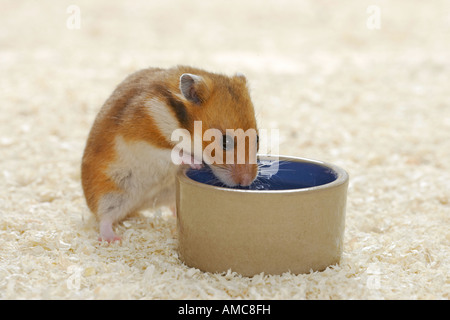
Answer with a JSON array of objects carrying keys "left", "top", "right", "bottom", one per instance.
[{"left": 81, "top": 66, "right": 258, "bottom": 242}]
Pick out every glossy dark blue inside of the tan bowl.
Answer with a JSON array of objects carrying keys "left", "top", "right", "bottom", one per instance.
[{"left": 186, "top": 160, "right": 338, "bottom": 190}]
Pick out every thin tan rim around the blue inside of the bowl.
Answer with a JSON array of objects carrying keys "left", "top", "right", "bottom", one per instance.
[{"left": 176, "top": 154, "right": 349, "bottom": 194}]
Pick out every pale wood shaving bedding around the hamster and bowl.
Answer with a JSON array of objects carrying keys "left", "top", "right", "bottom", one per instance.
[{"left": 0, "top": 0, "right": 450, "bottom": 299}]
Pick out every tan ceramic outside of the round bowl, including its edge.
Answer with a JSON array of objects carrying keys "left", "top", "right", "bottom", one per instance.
[{"left": 176, "top": 156, "right": 348, "bottom": 276}]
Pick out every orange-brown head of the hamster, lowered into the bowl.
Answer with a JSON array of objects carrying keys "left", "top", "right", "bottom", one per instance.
[{"left": 180, "top": 72, "right": 259, "bottom": 187}]
